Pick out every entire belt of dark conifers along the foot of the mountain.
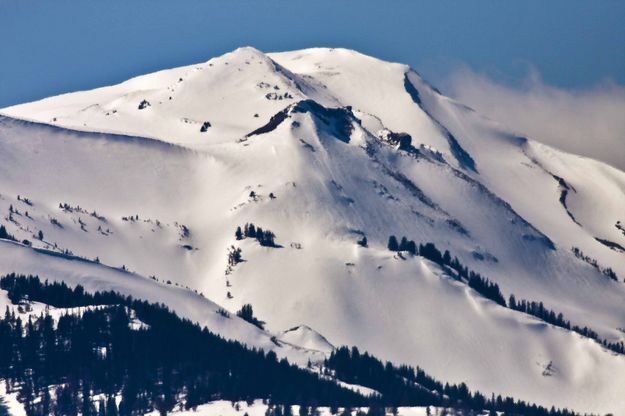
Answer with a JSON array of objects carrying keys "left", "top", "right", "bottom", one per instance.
[{"left": 0, "top": 274, "right": 572, "bottom": 416}]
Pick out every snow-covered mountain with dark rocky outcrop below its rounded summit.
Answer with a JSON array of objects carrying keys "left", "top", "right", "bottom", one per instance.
[{"left": 0, "top": 48, "right": 625, "bottom": 412}]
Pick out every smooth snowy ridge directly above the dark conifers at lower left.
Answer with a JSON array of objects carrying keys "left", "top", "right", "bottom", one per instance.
[{"left": 0, "top": 240, "right": 325, "bottom": 365}]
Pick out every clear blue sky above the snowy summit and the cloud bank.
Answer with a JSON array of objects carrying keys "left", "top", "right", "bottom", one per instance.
[{"left": 0, "top": 0, "right": 625, "bottom": 108}]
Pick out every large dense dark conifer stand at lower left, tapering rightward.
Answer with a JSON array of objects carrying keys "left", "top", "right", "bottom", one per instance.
[{"left": 0, "top": 275, "right": 360, "bottom": 415}]
